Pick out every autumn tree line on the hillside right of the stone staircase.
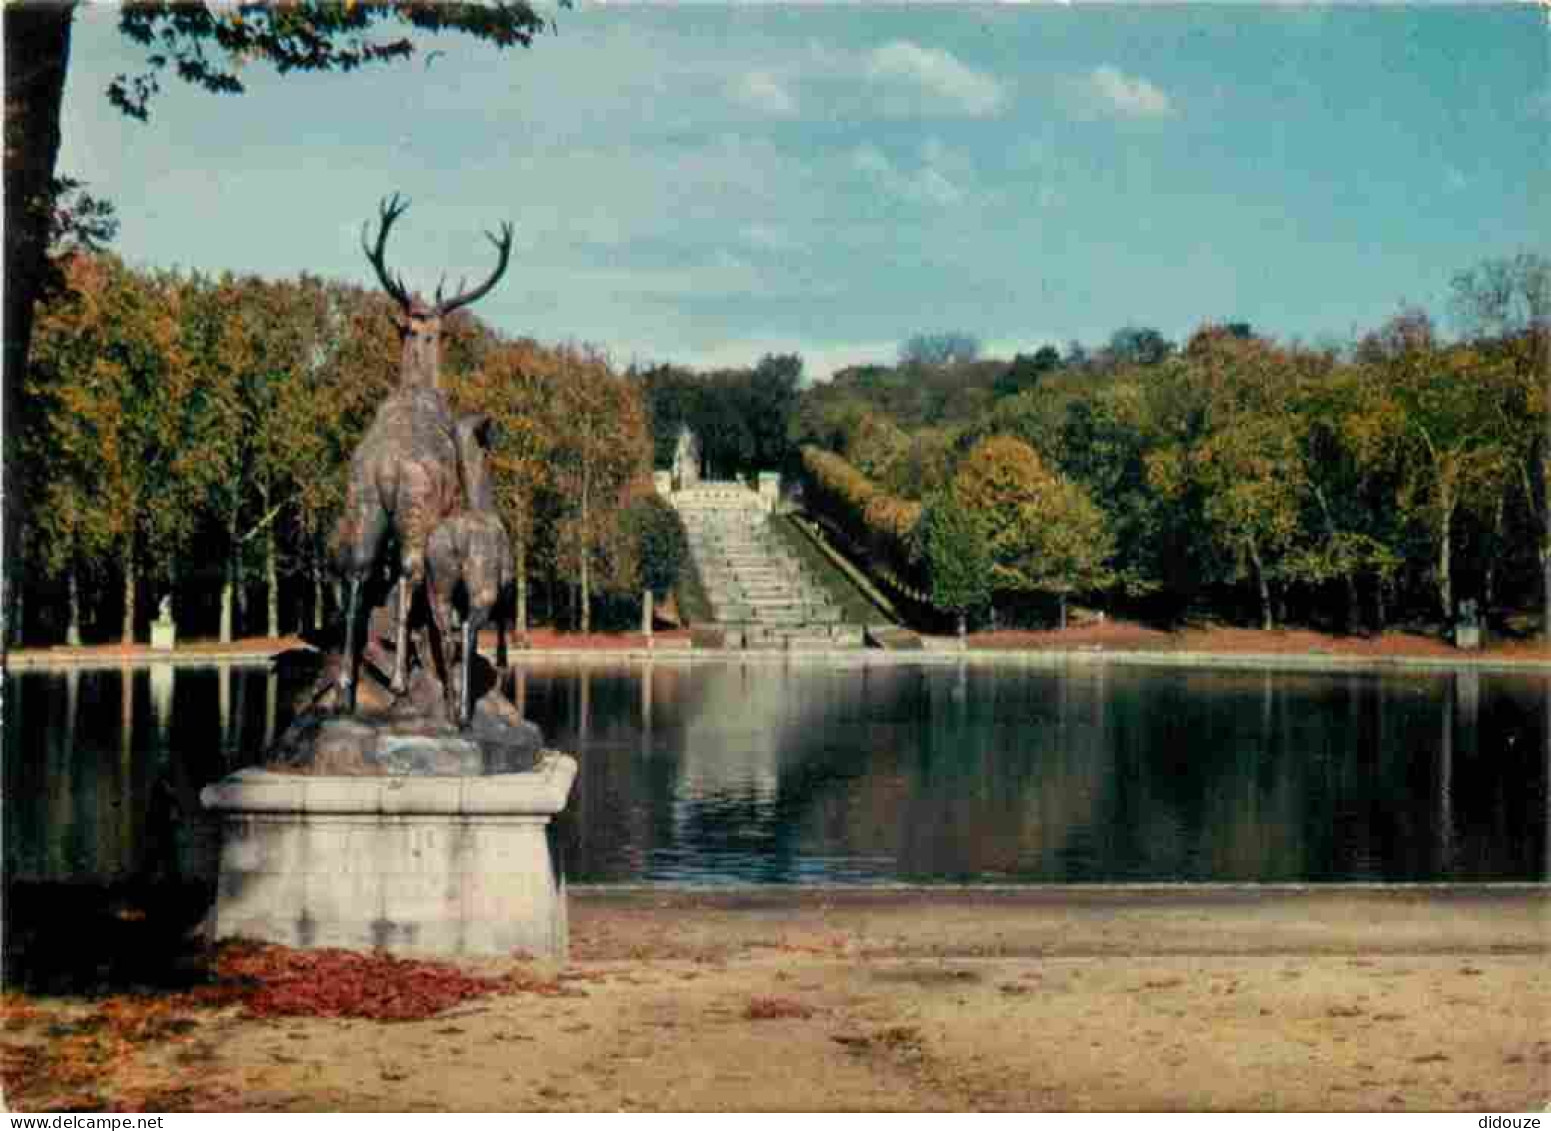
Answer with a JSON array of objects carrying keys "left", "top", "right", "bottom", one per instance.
[{"left": 793, "top": 253, "right": 1551, "bottom": 645}]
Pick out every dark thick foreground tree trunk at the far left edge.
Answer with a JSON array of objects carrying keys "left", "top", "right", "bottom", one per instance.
[{"left": 0, "top": 3, "right": 74, "bottom": 670}]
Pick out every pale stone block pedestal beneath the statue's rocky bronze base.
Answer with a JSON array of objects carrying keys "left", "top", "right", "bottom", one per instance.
[{"left": 200, "top": 752, "right": 577, "bottom": 960}]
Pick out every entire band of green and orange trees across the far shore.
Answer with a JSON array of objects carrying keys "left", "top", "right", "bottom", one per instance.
[{"left": 19, "top": 238, "right": 1551, "bottom": 639}]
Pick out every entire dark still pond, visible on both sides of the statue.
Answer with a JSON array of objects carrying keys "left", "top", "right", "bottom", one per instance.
[{"left": 3, "top": 661, "right": 1551, "bottom": 886}]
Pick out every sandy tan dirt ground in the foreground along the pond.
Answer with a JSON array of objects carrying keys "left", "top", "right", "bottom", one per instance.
[{"left": 5, "top": 884, "right": 1551, "bottom": 1112}]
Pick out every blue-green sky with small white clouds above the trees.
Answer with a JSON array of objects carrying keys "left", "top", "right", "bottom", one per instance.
[{"left": 59, "top": 0, "right": 1551, "bottom": 380}]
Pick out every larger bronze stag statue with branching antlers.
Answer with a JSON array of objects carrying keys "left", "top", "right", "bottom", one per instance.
[{"left": 333, "top": 194, "right": 512, "bottom": 714}]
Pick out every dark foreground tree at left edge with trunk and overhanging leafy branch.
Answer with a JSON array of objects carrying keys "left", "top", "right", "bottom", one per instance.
[{"left": 0, "top": 0, "right": 565, "bottom": 655}]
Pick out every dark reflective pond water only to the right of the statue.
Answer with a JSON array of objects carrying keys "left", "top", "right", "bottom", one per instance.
[{"left": 524, "top": 662, "right": 1548, "bottom": 883}]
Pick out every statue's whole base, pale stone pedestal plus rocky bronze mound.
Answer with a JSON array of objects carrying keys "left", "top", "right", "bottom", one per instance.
[{"left": 200, "top": 638, "right": 577, "bottom": 959}]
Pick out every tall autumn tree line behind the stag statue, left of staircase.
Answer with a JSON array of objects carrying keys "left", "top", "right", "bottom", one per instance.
[{"left": 12, "top": 247, "right": 682, "bottom": 642}]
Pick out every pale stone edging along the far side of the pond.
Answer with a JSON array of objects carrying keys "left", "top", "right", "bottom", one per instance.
[{"left": 6, "top": 645, "right": 1551, "bottom": 675}]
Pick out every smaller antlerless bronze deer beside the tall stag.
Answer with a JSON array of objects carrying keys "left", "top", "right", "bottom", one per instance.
[{"left": 425, "top": 414, "right": 515, "bottom": 728}]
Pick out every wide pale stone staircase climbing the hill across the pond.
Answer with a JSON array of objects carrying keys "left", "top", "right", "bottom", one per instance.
[{"left": 673, "top": 490, "right": 862, "bottom": 649}]
